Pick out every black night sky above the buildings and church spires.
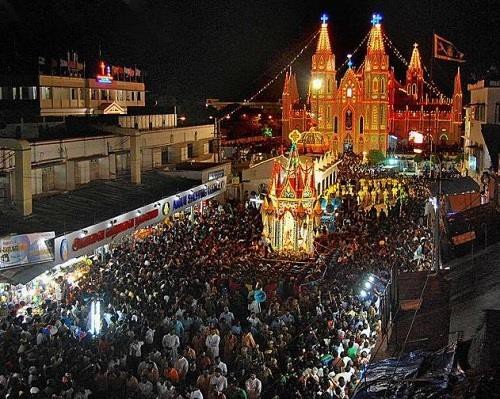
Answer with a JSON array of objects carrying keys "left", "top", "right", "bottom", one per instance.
[{"left": 0, "top": 0, "right": 500, "bottom": 120}]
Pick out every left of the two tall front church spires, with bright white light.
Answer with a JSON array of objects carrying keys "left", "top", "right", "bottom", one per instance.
[{"left": 309, "top": 15, "right": 337, "bottom": 139}]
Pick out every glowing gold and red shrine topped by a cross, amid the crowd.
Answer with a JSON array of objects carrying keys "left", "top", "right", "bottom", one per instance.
[{"left": 261, "top": 130, "right": 322, "bottom": 255}]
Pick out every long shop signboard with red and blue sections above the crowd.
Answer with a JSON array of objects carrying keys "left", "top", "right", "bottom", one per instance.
[{"left": 54, "top": 177, "right": 226, "bottom": 264}]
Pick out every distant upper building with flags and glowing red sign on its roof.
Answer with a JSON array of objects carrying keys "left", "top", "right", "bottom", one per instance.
[{"left": 0, "top": 58, "right": 146, "bottom": 123}]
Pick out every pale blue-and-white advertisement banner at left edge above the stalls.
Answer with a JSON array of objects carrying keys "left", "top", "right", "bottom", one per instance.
[{"left": 0, "top": 231, "right": 55, "bottom": 269}]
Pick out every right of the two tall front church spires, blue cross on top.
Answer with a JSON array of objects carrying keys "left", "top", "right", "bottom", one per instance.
[{"left": 363, "top": 14, "right": 389, "bottom": 153}]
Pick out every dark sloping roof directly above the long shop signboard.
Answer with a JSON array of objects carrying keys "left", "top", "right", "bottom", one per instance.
[{"left": 0, "top": 171, "right": 200, "bottom": 236}]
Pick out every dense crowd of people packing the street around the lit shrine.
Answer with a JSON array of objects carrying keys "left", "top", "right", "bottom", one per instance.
[{"left": 0, "top": 155, "right": 431, "bottom": 399}]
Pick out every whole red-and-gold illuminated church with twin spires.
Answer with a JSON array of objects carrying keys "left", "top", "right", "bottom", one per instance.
[{"left": 282, "top": 14, "right": 462, "bottom": 154}]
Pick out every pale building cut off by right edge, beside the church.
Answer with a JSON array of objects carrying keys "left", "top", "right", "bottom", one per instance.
[{"left": 464, "top": 74, "right": 500, "bottom": 179}]
